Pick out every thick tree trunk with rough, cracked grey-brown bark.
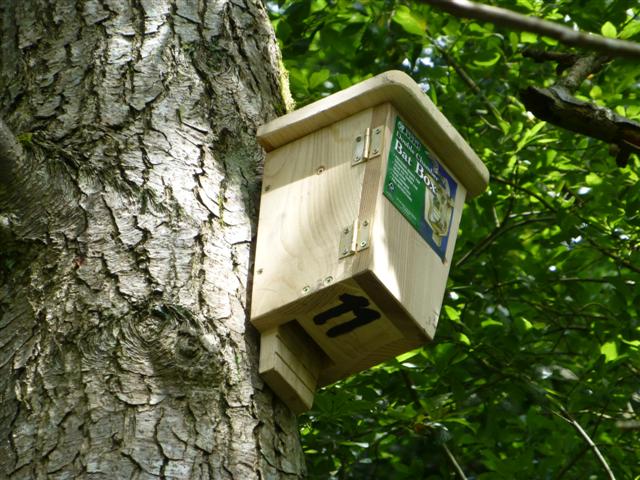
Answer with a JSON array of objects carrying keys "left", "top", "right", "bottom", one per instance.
[{"left": 0, "top": 0, "right": 304, "bottom": 479}]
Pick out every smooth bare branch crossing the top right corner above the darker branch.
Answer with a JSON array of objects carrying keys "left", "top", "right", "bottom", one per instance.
[{"left": 420, "top": 0, "right": 640, "bottom": 58}]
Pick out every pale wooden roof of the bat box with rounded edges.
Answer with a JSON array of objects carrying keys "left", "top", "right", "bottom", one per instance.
[{"left": 258, "top": 71, "right": 489, "bottom": 197}]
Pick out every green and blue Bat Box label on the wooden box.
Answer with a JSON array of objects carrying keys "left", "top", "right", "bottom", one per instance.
[{"left": 384, "top": 117, "right": 458, "bottom": 261}]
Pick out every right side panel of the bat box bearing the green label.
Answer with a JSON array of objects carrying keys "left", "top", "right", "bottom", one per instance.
[{"left": 371, "top": 109, "right": 466, "bottom": 338}]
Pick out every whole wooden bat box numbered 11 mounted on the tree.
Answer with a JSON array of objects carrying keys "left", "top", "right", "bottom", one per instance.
[{"left": 251, "top": 71, "right": 489, "bottom": 413}]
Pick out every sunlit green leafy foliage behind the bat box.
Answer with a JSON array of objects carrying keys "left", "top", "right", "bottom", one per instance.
[{"left": 270, "top": 0, "right": 640, "bottom": 479}]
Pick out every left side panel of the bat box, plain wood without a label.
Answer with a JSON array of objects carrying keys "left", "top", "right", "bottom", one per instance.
[{"left": 251, "top": 108, "right": 374, "bottom": 331}]
